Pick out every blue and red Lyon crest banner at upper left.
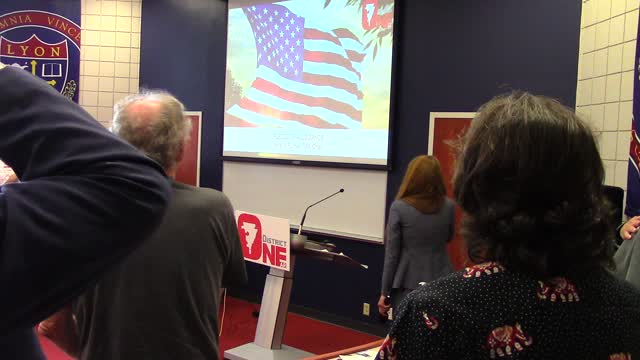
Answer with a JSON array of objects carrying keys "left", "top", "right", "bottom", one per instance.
[{"left": 0, "top": 10, "right": 80, "bottom": 102}]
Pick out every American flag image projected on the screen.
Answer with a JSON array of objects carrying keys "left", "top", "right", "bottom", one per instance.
[{"left": 225, "top": 4, "right": 365, "bottom": 129}]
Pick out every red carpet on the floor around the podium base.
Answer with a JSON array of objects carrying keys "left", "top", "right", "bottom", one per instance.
[{"left": 40, "top": 298, "right": 379, "bottom": 360}]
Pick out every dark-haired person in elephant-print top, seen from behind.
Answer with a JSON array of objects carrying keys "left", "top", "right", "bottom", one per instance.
[{"left": 378, "top": 93, "right": 640, "bottom": 360}]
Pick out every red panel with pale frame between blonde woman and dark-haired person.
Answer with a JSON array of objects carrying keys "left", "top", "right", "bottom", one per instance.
[{"left": 427, "top": 112, "right": 476, "bottom": 270}]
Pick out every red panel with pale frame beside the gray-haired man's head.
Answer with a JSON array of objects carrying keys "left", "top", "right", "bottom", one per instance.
[{"left": 176, "top": 111, "right": 202, "bottom": 186}]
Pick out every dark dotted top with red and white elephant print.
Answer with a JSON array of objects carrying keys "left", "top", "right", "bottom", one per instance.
[{"left": 377, "top": 263, "right": 640, "bottom": 360}]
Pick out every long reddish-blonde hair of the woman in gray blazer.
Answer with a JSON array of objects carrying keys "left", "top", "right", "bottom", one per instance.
[{"left": 396, "top": 155, "right": 446, "bottom": 214}]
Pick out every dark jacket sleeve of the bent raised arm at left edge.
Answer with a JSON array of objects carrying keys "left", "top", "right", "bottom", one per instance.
[{"left": 0, "top": 67, "right": 170, "bottom": 359}]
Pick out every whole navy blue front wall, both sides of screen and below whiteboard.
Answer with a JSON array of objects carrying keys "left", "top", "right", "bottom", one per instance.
[{"left": 140, "top": 0, "right": 581, "bottom": 332}]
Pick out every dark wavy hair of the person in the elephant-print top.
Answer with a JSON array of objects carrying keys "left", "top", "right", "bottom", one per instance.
[{"left": 453, "top": 93, "right": 614, "bottom": 278}]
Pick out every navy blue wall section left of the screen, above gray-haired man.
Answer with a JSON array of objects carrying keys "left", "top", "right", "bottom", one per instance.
[{"left": 140, "top": 0, "right": 227, "bottom": 189}]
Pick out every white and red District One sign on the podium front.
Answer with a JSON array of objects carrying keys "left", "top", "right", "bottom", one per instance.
[{"left": 235, "top": 211, "right": 291, "bottom": 271}]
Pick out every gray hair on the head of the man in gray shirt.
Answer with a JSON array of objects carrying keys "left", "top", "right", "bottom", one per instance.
[{"left": 112, "top": 90, "right": 191, "bottom": 169}]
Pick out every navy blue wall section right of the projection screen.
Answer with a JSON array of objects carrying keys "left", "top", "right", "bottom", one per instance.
[{"left": 387, "top": 0, "right": 581, "bottom": 205}]
